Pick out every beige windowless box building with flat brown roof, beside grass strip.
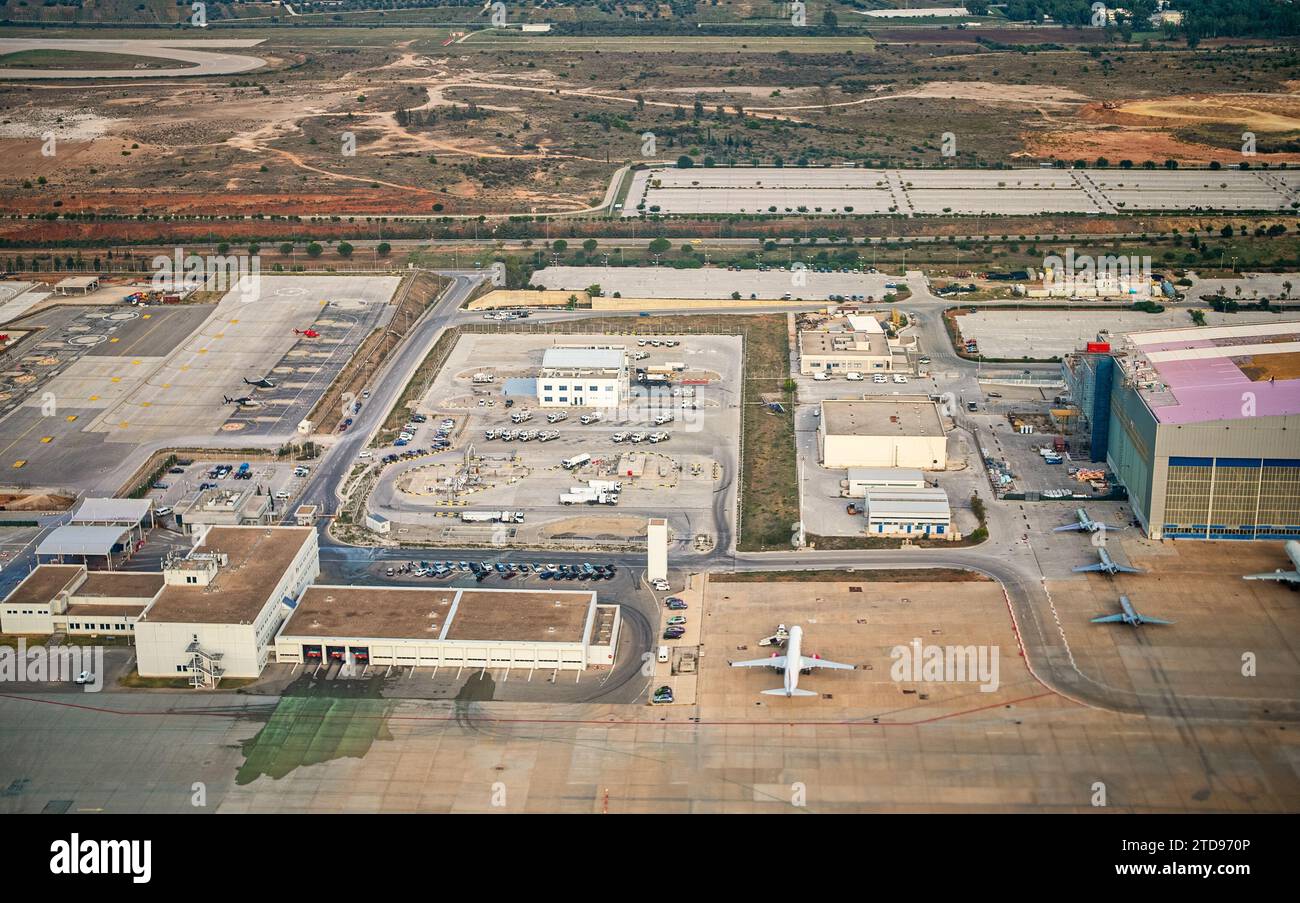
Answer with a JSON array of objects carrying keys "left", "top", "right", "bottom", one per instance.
[{"left": 818, "top": 395, "right": 948, "bottom": 470}]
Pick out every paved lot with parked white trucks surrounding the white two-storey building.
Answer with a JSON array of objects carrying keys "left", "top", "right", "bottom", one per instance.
[{"left": 371, "top": 334, "right": 741, "bottom": 551}]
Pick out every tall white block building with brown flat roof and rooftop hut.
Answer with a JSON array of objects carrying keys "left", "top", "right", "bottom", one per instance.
[{"left": 135, "top": 526, "right": 320, "bottom": 686}]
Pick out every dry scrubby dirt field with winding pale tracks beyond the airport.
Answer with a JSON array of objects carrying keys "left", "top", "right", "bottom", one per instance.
[{"left": 0, "top": 29, "right": 1300, "bottom": 216}]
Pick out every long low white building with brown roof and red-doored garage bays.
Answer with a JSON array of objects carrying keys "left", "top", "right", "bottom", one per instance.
[{"left": 276, "top": 585, "right": 620, "bottom": 670}]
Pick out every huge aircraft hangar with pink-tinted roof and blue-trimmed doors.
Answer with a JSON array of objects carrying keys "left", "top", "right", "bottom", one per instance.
[{"left": 1105, "top": 320, "right": 1300, "bottom": 539}]
